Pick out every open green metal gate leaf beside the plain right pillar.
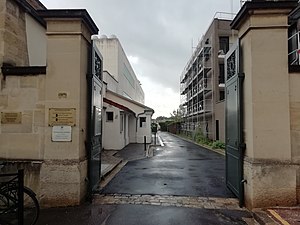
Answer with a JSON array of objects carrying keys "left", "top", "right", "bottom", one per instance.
[{"left": 225, "top": 40, "right": 245, "bottom": 206}]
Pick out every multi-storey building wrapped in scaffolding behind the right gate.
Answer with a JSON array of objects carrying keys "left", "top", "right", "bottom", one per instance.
[{"left": 180, "top": 13, "right": 236, "bottom": 142}]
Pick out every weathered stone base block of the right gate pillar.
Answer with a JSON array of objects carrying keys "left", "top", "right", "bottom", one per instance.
[{"left": 244, "top": 161, "right": 297, "bottom": 209}]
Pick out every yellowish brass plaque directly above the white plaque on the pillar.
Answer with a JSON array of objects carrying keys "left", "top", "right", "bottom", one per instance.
[{"left": 49, "top": 108, "right": 76, "bottom": 126}]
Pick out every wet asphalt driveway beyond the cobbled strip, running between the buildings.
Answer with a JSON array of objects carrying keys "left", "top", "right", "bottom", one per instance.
[{"left": 103, "top": 133, "right": 234, "bottom": 197}]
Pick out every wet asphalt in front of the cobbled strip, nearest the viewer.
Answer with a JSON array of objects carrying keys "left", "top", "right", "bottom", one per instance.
[{"left": 37, "top": 202, "right": 251, "bottom": 225}]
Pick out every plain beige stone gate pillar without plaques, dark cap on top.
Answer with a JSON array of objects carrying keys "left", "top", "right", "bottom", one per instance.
[{"left": 231, "top": 1, "right": 299, "bottom": 208}]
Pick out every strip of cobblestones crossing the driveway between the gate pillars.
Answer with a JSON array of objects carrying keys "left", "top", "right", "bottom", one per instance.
[{"left": 94, "top": 194, "right": 246, "bottom": 210}]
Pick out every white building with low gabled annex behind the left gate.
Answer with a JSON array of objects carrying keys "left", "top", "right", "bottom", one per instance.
[{"left": 95, "top": 35, "right": 154, "bottom": 150}]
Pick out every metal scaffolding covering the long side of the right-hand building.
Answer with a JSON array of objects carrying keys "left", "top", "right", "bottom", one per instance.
[{"left": 180, "top": 38, "right": 213, "bottom": 138}]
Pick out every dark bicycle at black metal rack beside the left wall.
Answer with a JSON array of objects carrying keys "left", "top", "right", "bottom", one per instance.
[{"left": 0, "top": 163, "right": 40, "bottom": 225}]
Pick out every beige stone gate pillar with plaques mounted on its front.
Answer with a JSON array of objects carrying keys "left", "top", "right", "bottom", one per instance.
[{"left": 39, "top": 9, "right": 98, "bottom": 206}]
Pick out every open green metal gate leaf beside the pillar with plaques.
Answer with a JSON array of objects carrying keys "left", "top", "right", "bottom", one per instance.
[{"left": 87, "top": 42, "right": 103, "bottom": 197}]
